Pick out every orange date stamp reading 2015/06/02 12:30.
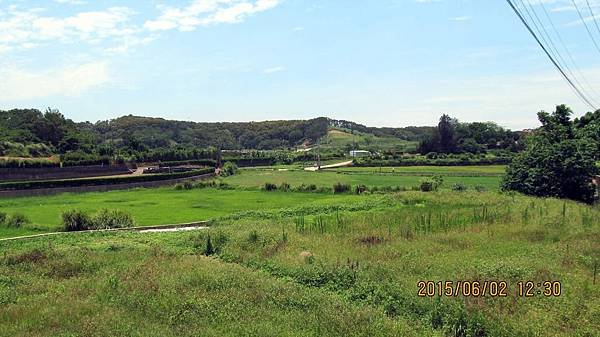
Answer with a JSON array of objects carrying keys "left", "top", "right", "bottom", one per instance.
[{"left": 417, "top": 281, "right": 562, "bottom": 297}]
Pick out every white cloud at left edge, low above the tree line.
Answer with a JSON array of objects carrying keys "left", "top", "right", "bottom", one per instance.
[{"left": 0, "top": 61, "right": 110, "bottom": 102}]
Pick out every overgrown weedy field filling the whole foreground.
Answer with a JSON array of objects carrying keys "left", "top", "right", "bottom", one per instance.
[{"left": 0, "top": 190, "right": 600, "bottom": 337}]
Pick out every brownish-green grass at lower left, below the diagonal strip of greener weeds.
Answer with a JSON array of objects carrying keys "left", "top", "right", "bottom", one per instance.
[{"left": 0, "top": 235, "right": 416, "bottom": 337}]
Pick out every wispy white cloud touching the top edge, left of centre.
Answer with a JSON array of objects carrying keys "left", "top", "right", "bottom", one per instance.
[{"left": 144, "top": 0, "right": 280, "bottom": 31}]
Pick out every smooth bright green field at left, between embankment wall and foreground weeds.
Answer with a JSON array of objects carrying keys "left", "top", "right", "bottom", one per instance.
[{"left": 0, "top": 187, "right": 360, "bottom": 238}]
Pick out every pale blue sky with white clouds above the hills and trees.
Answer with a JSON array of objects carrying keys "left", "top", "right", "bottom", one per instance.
[{"left": 0, "top": 0, "right": 600, "bottom": 129}]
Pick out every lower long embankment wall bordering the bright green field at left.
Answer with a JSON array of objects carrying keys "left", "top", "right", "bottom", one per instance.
[{"left": 0, "top": 173, "right": 215, "bottom": 198}]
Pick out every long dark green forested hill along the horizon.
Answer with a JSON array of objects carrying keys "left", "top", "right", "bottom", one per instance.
[{"left": 0, "top": 109, "right": 440, "bottom": 157}]
